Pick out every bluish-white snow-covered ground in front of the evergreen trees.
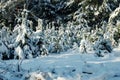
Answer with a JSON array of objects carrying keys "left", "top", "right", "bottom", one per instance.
[{"left": 0, "top": 49, "right": 120, "bottom": 80}]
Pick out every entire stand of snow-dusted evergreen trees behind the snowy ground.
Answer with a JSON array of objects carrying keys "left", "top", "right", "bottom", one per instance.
[{"left": 0, "top": 0, "right": 120, "bottom": 59}]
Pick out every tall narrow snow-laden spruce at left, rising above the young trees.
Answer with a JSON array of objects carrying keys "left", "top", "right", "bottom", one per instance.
[{"left": 8, "top": 9, "right": 32, "bottom": 59}]
